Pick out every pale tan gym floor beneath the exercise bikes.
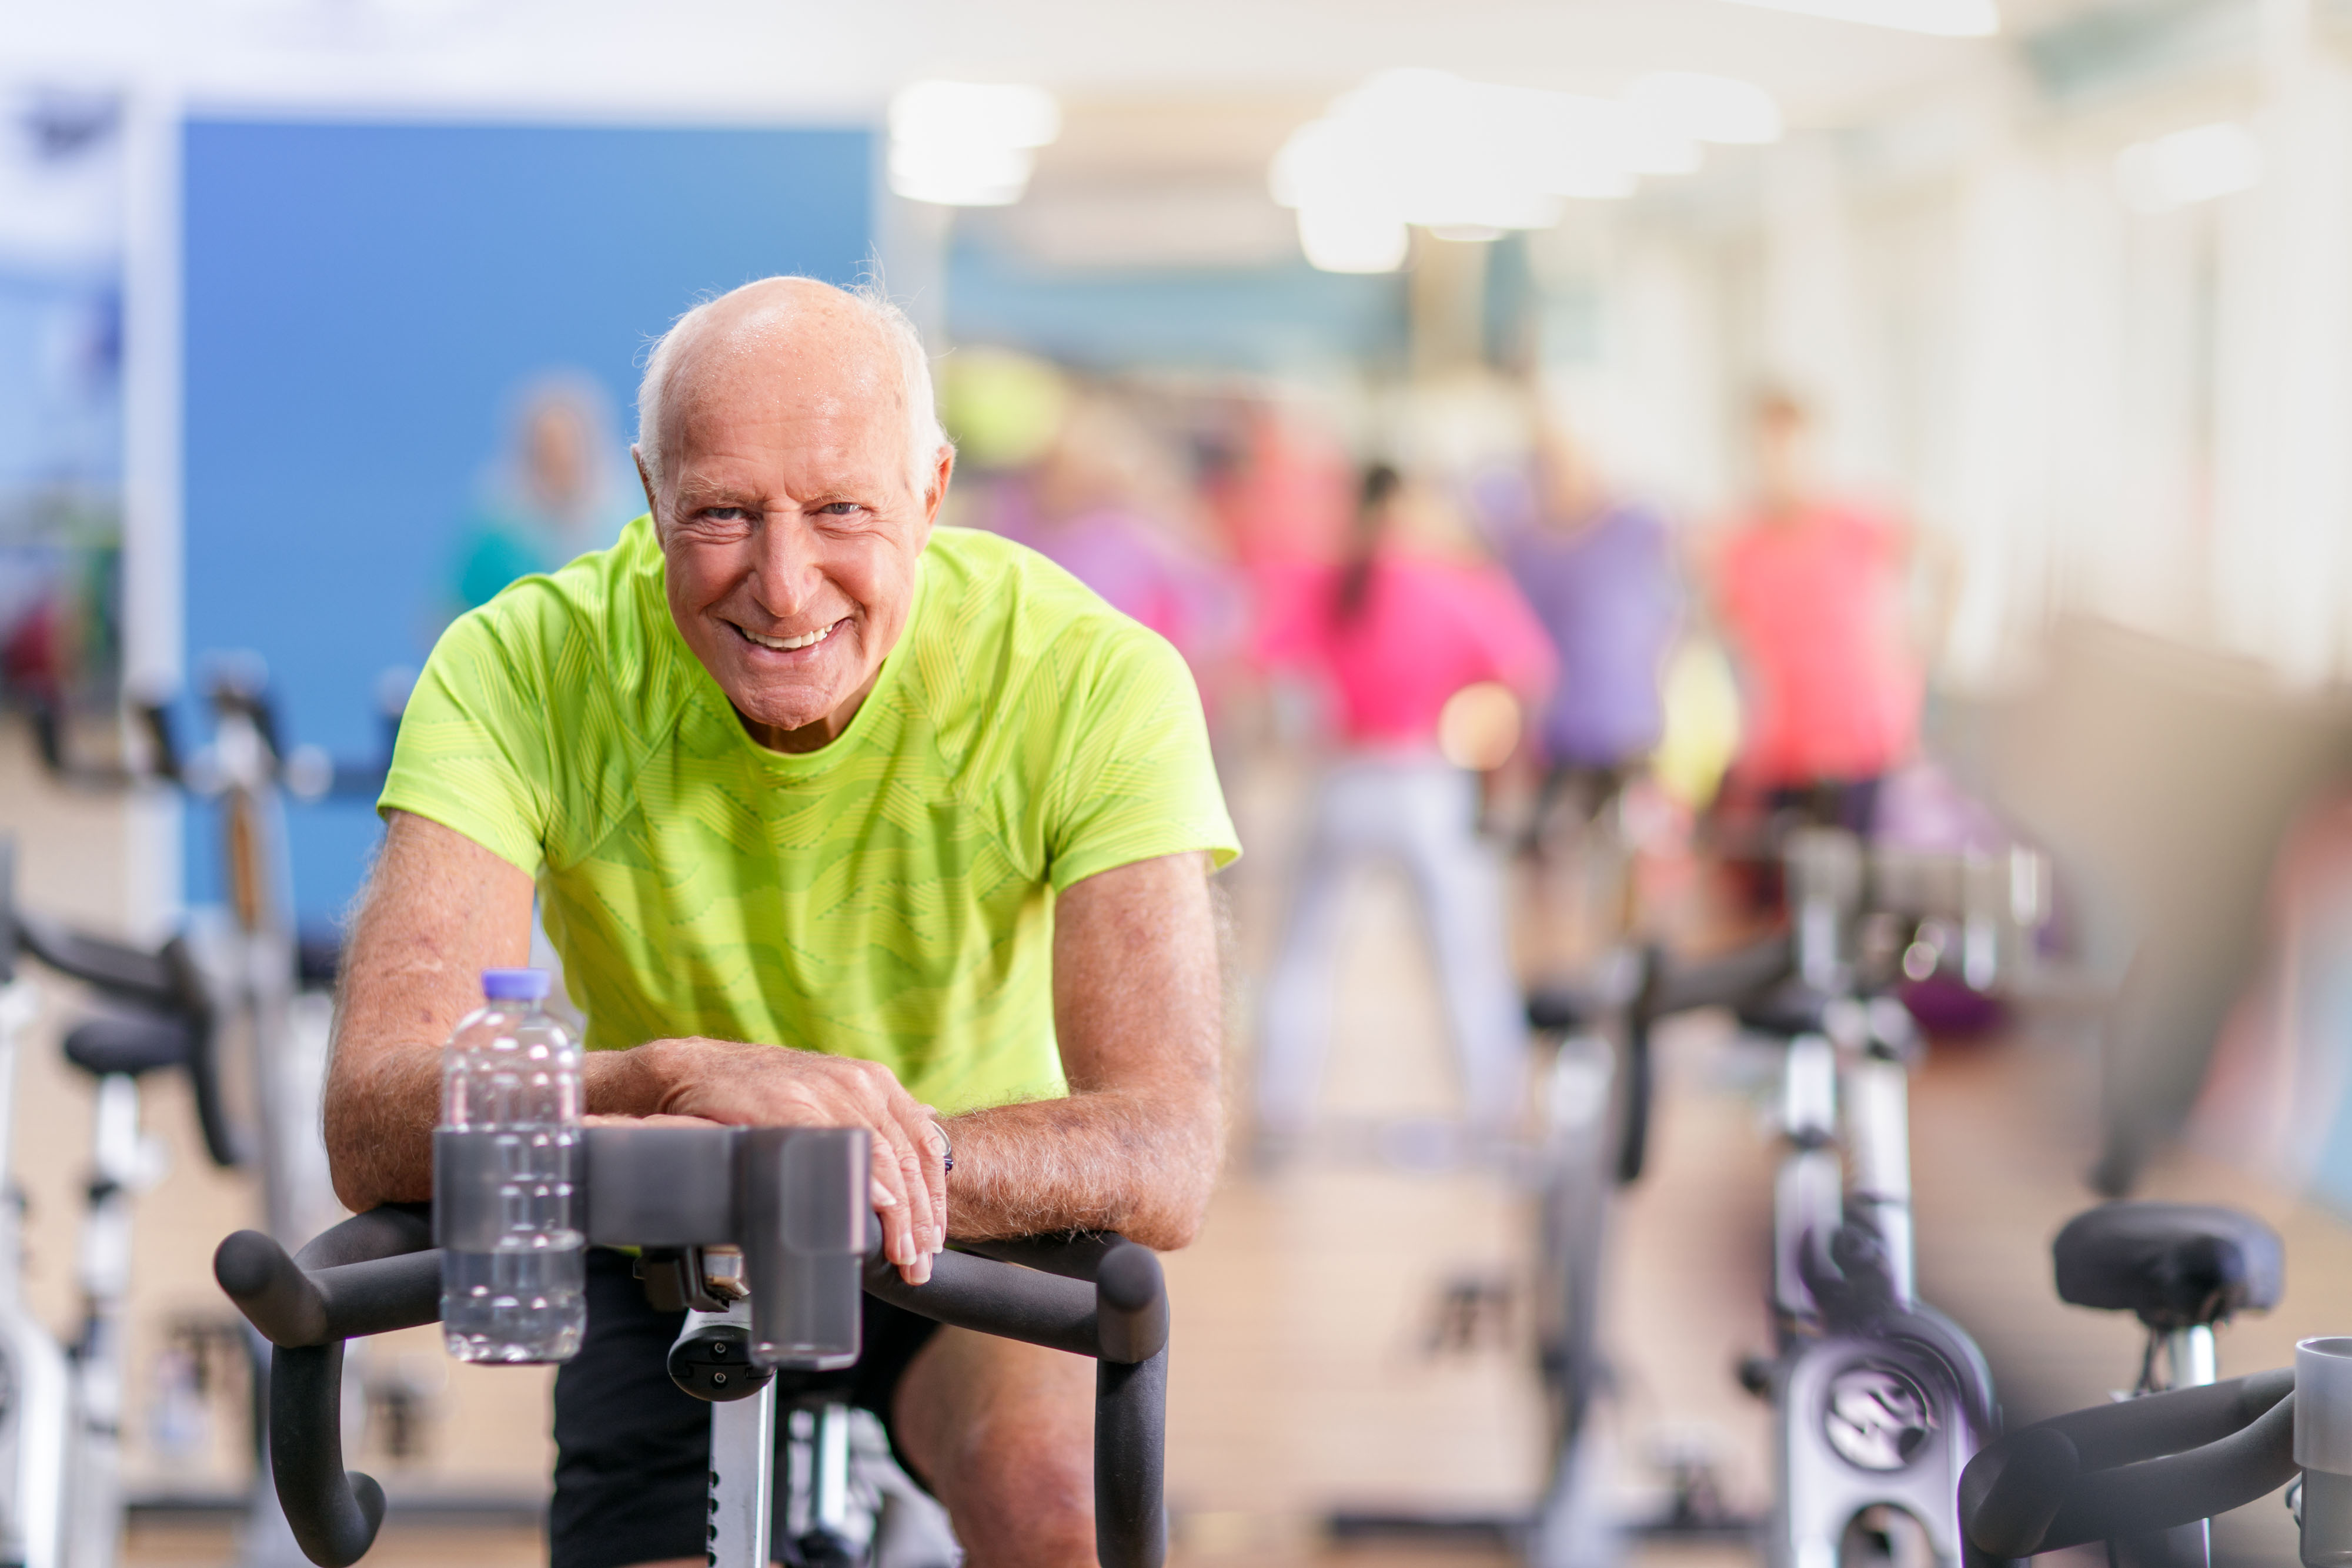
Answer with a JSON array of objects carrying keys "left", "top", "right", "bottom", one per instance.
[{"left": 0, "top": 731, "right": 2352, "bottom": 1568}]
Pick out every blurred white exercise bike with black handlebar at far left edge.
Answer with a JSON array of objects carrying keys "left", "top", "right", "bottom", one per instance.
[{"left": 0, "top": 839, "right": 238, "bottom": 1568}]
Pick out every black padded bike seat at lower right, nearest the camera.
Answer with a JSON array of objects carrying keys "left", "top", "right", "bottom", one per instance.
[{"left": 2051, "top": 1203, "right": 2286, "bottom": 1328}]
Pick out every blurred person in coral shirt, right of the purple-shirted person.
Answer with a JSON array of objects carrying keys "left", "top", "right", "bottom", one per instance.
[{"left": 1708, "top": 390, "right": 1926, "bottom": 837}]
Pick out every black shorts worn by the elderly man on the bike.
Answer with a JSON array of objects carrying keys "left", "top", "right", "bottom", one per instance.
[{"left": 548, "top": 1248, "right": 938, "bottom": 1568}]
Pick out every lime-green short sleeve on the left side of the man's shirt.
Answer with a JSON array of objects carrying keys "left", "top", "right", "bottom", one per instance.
[{"left": 376, "top": 595, "right": 555, "bottom": 877}]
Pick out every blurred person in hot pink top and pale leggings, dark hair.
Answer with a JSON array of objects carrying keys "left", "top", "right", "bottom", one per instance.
[{"left": 1258, "top": 466, "right": 1555, "bottom": 1156}]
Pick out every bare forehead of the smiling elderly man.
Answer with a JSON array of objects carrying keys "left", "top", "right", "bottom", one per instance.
[{"left": 661, "top": 313, "right": 906, "bottom": 466}]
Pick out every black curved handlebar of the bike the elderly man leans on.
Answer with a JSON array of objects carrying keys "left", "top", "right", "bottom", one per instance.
[{"left": 214, "top": 1203, "right": 1169, "bottom": 1568}]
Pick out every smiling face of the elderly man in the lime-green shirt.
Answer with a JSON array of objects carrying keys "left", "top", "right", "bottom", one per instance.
[{"left": 640, "top": 322, "right": 950, "bottom": 753}]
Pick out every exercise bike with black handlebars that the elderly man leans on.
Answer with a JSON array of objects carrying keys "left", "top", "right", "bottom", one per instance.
[{"left": 214, "top": 1126, "right": 1169, "bottom": 1568}]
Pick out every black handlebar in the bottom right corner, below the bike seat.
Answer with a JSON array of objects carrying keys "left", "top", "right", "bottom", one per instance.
[{"left": 1959, "top": 1368, "right": 2296, "bottom": 1559}]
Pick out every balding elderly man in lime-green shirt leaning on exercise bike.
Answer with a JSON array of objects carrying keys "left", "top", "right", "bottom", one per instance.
[{"left": 327, "top": 278, "right": 1240, "bottom": 1568}]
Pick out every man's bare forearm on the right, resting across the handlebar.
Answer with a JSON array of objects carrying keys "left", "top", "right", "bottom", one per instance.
[{"left": 946, "top": 1091, "right": 1223, "bottom": 1251}]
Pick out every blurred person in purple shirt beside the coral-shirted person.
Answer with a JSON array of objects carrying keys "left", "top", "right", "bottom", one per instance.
[{"left": 1475, "top": 423, "right": 1682, "bottom": 839}]
